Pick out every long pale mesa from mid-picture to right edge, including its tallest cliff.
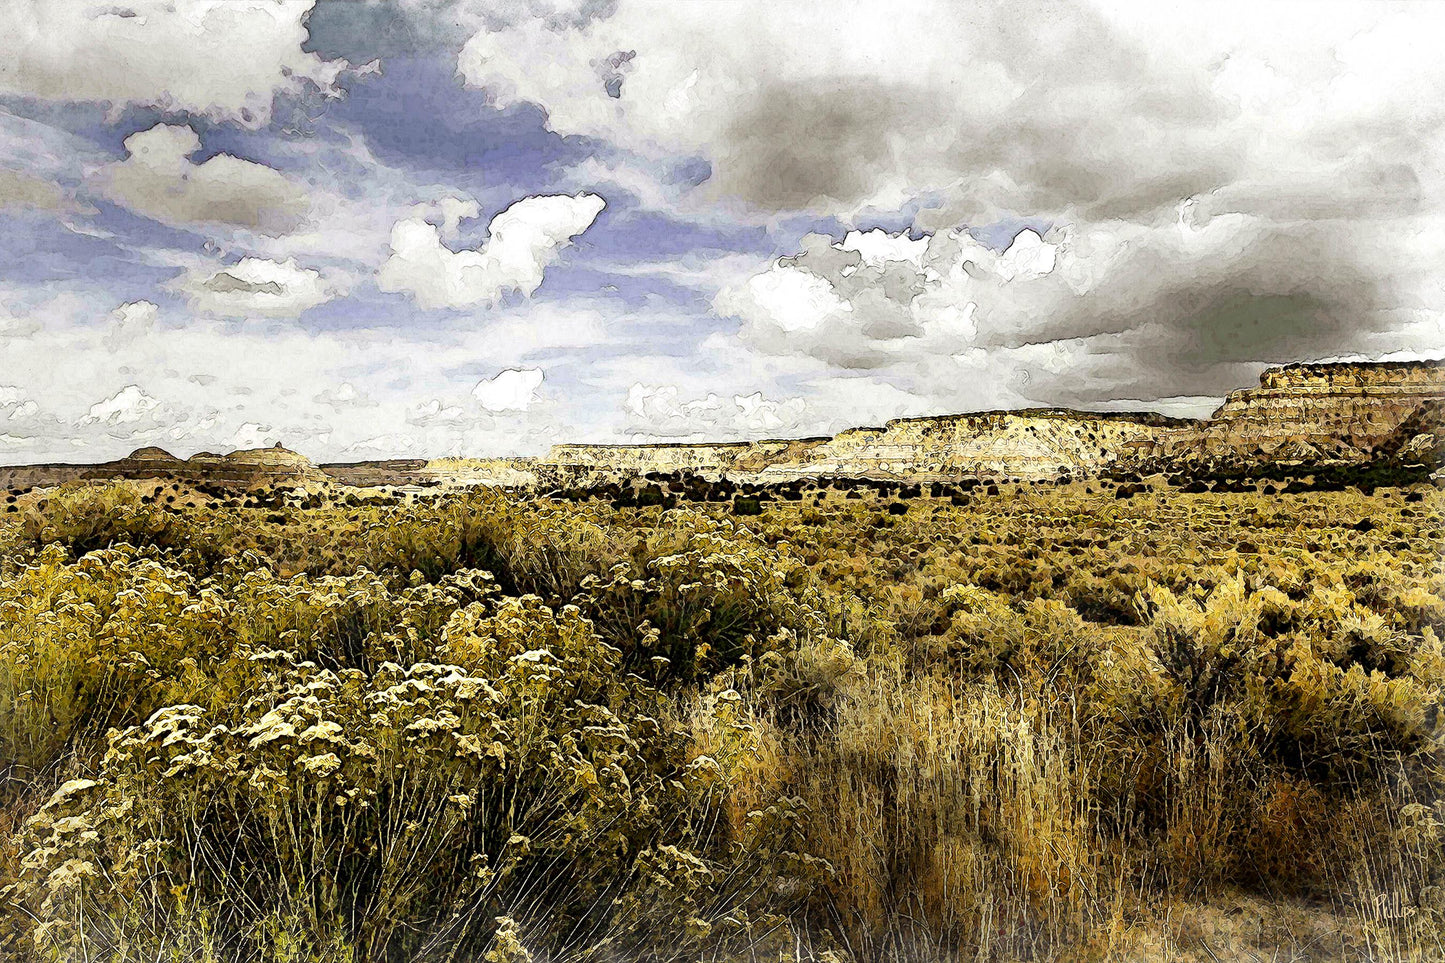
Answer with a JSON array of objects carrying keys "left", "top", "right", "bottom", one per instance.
[{"left": 543, "top": 361, "right": 1445, "bottom": 482}]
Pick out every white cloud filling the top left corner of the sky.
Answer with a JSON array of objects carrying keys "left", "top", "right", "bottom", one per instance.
[{"left": 0, "top": 0, "right": 345, "bottom": 126}]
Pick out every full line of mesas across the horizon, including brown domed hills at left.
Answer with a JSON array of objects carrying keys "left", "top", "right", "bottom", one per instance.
[{"left": 0, "top": 361, "right": 1445, "bottom": 489}]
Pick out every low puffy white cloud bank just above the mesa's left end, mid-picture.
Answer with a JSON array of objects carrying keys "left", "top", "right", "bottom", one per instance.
[{"left": 623, "top": 382, "right": 811, "bottom": 441}]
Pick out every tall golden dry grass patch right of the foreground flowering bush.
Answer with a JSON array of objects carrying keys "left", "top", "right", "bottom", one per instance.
[{"left": 738, "top": 659, "right": 1124, "bottom": 960}]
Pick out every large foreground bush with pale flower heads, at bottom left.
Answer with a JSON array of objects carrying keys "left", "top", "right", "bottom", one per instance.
[{"left": 14, "top": 597, "right": 814, "bottom": 960}]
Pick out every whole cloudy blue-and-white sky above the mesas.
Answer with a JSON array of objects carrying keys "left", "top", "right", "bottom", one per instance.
[{"left": 0, "top": 0, "right": 1445, "bottom": 464}]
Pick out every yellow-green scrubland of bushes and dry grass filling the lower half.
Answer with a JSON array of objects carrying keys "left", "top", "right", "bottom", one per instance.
[{"left": 0, "top": 483, "right": 1445, "bottom": 963}]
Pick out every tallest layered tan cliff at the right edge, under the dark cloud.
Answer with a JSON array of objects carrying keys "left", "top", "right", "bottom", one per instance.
[{"left": 1155, "top": 361, "right": 1445, "bottom": 464}]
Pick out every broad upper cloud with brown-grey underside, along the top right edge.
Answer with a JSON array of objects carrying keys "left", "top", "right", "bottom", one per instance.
[{"left": 458, "top": 0, "right": 1445, "bottom": 224}]
